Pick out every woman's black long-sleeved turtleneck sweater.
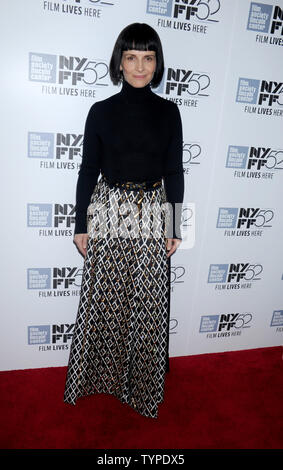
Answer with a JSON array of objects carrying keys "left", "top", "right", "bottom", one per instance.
[{"left": 75, "top": 80, "right": 184, "bottom": 239}]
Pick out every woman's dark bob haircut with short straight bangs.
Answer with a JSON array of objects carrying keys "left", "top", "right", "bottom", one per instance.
[{"left": 109, "top": 23, "right": 164, "bottom": 88}]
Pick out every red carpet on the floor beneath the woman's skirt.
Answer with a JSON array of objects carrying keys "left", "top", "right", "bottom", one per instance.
[{"left": 0, "top": 347, "right": 283, "bottom": 449}]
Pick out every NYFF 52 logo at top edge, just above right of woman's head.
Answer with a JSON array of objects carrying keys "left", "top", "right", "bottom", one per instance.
[{"left": 146, "top": 0, "right": 221, "bottom": 34}]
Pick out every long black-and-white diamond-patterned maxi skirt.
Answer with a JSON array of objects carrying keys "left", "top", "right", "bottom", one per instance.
[{"left": 64, "top": 175, "right": 170, "bottom": 418}]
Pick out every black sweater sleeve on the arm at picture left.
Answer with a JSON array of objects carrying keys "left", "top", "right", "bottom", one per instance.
[{"left": 74, "top": 103, "right": 101, "bottom": 234}]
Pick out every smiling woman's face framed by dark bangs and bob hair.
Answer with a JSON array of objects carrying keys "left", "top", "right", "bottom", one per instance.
[{"left": 120, "top": 49, "right": 156, "bottom": 88}]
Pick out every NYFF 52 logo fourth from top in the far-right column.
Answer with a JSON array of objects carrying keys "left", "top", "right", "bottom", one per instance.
[{"left": 216, "top": 207, "right": 274, "bottom": 237}]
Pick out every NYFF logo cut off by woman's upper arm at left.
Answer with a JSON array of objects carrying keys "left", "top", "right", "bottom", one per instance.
[{"left": 28, "top": 132, "right": 83, "bottom": 170}]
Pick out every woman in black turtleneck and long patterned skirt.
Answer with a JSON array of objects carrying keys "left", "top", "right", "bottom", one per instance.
[{"left": 64, "top": 23, "right": 184, "bottom": 418}]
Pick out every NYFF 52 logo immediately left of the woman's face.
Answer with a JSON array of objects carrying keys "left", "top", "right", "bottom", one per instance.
[{"left": 29, "top": 52, "right": 108, "bottom": 98}]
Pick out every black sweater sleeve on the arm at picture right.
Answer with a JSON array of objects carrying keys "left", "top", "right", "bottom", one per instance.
[{"left": 164, "top": 103, "right": 184, "bottom": 240}]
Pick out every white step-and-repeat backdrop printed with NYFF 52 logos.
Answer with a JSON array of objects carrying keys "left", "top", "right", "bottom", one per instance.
[{"left": 0, "top": 0, "right": 283, "bottom": 370}]
